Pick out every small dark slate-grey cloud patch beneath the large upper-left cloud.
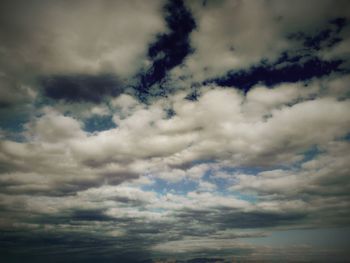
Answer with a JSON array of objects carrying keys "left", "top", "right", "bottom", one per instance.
[{"left": 41, "top": 74, "right": 122, "bottom": 103}]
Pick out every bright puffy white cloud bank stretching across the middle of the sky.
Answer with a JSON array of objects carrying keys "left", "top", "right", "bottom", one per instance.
[{"left": 2, "top": 84, "right": 350, "bottom": 196}]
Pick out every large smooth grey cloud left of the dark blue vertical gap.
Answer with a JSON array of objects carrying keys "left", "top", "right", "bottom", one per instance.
[{"left": 1, "top": 1, "right": 164, "bottom": 76}]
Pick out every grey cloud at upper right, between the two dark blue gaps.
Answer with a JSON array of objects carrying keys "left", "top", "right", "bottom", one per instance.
[{"left": 180, "top": 1, "right": 349, "bottom": 80}]
